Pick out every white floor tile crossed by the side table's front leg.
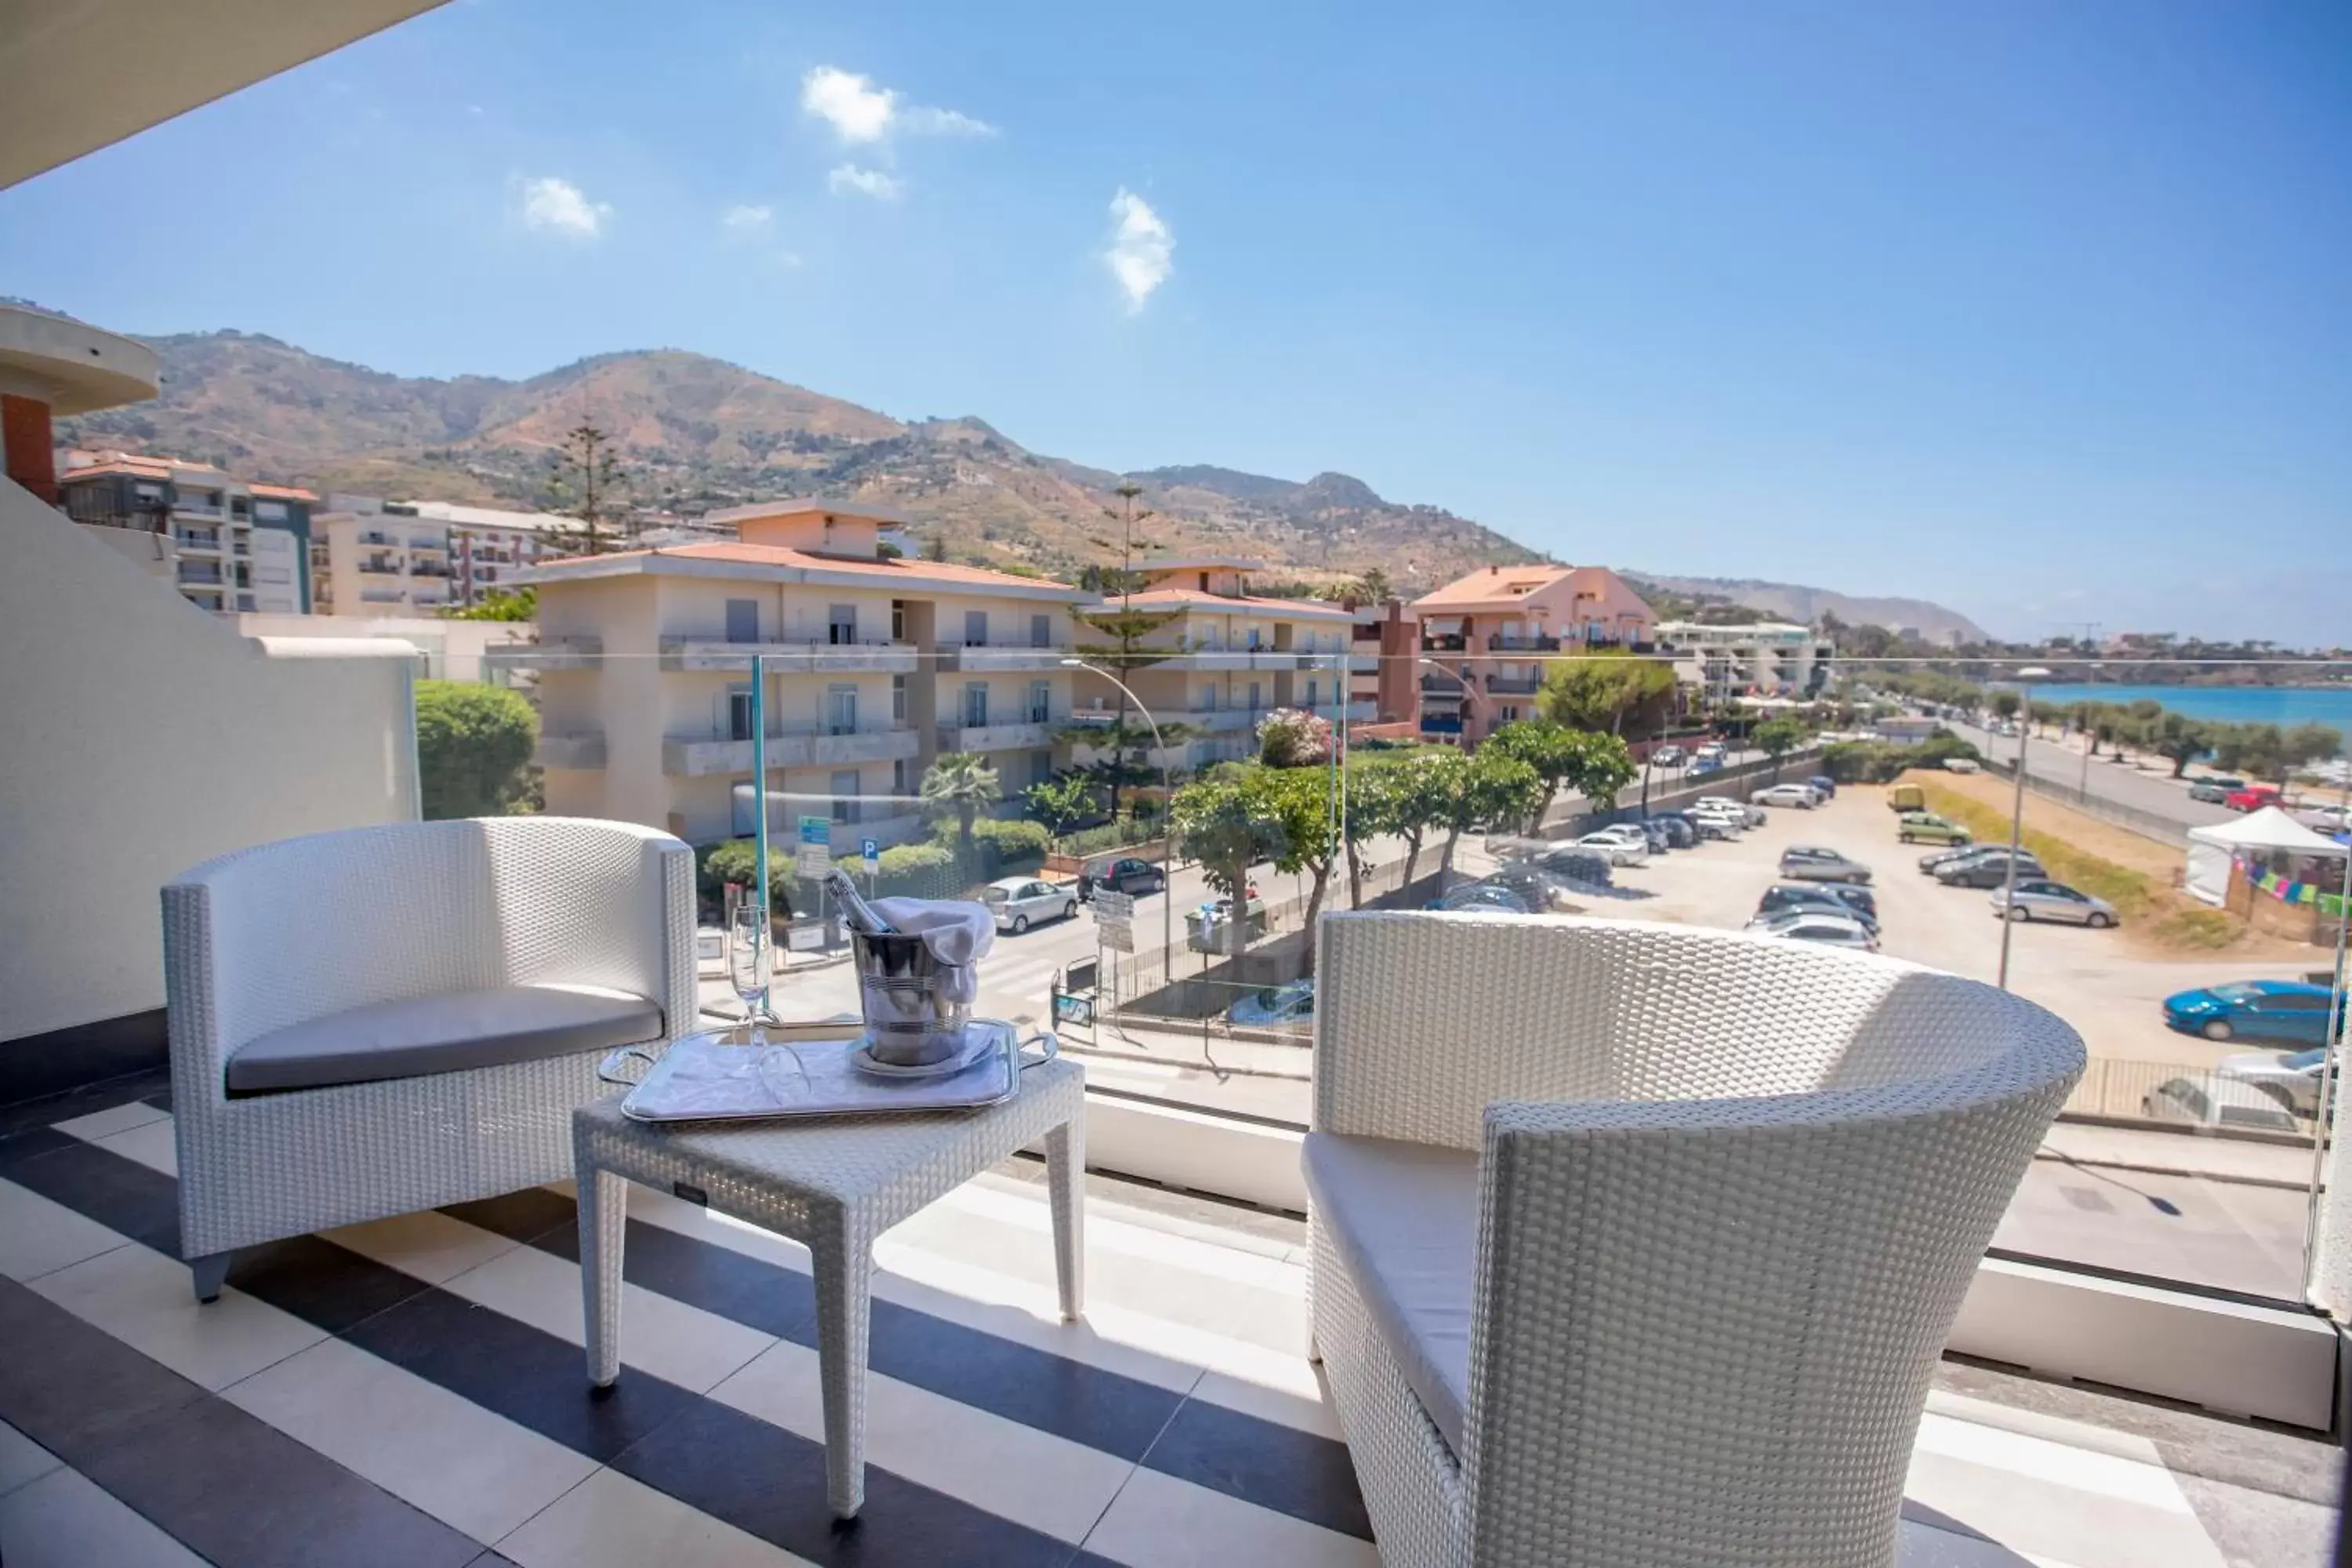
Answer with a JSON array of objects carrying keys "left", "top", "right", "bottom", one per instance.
[{"left": 710, "top": 1340, "right": 1134, "bottom": 1544}]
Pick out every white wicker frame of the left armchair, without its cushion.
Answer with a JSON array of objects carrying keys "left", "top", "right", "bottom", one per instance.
[{"left": 162, "top": 815, "right": 696, "bottom": 1300}]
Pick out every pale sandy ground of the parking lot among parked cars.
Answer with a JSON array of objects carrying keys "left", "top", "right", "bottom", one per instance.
[{"left": 1578, "top": 785, "right": 2326, "bottom": 1067}]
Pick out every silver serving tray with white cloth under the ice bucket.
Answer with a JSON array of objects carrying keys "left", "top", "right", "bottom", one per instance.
[{"left": 597, "top": 1018, "right": 1061, "bottom": 1121}]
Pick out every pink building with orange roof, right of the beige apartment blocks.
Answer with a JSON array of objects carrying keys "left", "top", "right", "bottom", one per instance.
[{"left": 1414, "top": 567, "right": 1658, "bottom": 746}]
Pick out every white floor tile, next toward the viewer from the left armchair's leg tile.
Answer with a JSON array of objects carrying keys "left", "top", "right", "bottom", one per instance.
[{"left": 221, "top": 1340, "right": 597, "bottom": 1540}]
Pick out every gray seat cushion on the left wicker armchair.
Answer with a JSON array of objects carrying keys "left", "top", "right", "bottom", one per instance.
[{"left": 228, "top": 985, "right": 661, "bottom": 1093}]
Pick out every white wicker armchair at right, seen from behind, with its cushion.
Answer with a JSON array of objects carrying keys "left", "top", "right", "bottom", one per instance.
[{"left": 1305, "top": 914, "right": 2084, "bottom": 1568}]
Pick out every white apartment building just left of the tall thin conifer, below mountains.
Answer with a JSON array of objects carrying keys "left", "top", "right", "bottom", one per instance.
[{"left": 310, "top": 494, "right": 574, "bottom": 616}]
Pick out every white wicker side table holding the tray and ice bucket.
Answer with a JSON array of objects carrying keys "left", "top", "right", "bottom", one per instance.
[{"left": 572, "top": 1058, "right": 1087, "bottom": 1519}]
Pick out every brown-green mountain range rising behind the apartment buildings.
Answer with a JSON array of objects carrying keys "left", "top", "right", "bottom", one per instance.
[{"left": 59, "top": 332, "right": 1536, "bottom": 590}]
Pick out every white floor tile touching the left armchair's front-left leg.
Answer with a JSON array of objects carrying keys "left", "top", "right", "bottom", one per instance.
[{"left": 31, "top": 1246, "right": 327, "bottom": 1389}]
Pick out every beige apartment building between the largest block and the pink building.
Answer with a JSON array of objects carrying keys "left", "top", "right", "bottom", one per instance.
[{"left": 1075, "top": 560, "right": 1381, "bottom": 769}]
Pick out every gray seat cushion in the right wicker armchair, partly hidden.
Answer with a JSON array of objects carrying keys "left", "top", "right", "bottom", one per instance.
[{"left": 1305, "top": 1133, "right": 1477, "bottom": 1455}]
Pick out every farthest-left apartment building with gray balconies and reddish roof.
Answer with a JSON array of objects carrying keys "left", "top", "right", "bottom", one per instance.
[{"left": 56, "top": 452, "right": 318, "bottom": 616}]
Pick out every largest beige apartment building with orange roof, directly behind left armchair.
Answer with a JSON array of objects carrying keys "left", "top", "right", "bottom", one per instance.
[{"left": 517, "top": 501, "right": 1089, "bottom": 853}]
